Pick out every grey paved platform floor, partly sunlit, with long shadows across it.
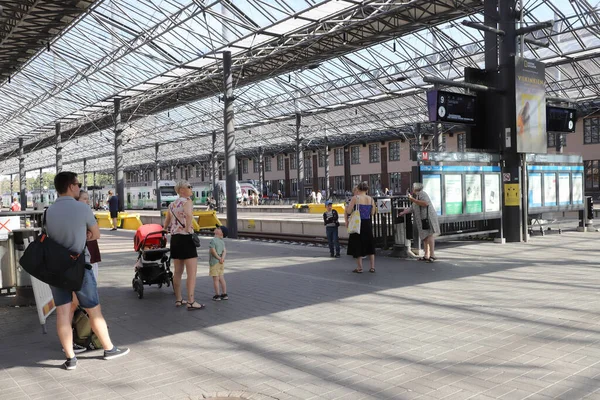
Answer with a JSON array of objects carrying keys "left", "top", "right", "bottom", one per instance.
[{"left": 0, "top": 230, "right": 600, "bottom": 400}]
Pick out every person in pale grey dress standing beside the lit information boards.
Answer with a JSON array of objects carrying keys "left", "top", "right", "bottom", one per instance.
[{"left": 399, "top": 182, "right": 440, "bottom": 262}]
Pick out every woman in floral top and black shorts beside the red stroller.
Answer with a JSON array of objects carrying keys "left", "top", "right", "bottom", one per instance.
[{"left": 164, "top": 181, "right": 205, "bottom": 311}]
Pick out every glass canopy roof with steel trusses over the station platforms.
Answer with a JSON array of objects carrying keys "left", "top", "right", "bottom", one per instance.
[{"left": 0, "top": 0, "right": 600, "bottom": 173}]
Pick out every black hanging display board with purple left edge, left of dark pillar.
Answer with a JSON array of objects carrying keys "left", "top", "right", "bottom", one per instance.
[{"left": 427, "top": 90, "right": 477, "bottom": 124}]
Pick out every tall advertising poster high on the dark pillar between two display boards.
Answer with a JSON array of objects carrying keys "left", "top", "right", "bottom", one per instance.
[{"left": 515, "top": 57, "right": 548, "bottom": 153}]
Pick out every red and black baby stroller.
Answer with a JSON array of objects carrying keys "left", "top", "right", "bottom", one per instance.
[{"left": 131, "top": 224, "right": 173, "bottom": 299}]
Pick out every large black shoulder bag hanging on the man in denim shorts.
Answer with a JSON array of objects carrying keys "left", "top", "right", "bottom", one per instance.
[{"left": 19, "top": 211, "right": 87, "bottom": 292}]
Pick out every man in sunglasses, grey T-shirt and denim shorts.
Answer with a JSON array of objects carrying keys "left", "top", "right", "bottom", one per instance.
[{"left": 46, "top": 171, "right": 129, "bottom": 370}]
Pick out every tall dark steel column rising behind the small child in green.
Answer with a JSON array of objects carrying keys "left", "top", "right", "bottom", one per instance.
[{"left": 223, "top": 51, "right": 237, "bottom": 239}]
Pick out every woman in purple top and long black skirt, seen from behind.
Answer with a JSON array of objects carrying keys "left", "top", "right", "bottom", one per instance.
[{"left": 345, "top": 182, "right": 375, "bottom": 274}]
